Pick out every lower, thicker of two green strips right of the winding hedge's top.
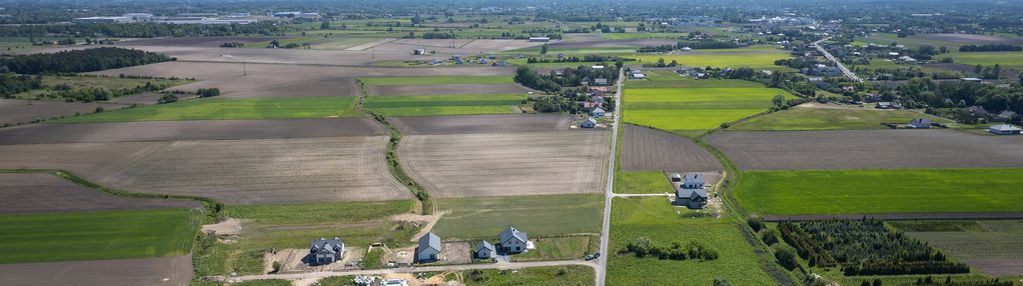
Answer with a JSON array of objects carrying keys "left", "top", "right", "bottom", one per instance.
[{"left": 363, "top": 94, "right": 526, "bottom": 116}]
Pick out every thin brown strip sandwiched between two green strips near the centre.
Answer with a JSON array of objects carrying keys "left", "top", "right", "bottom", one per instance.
[{"left": 368, "top": 84, "right": 533, "bottom": 96}]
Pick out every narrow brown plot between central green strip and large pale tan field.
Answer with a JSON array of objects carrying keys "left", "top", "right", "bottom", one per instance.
[{"left": 388, "top": 114, "right": 572, "bottom": 135}]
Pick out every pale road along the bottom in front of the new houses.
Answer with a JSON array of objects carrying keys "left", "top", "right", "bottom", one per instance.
[{"left": 227, "top": 260, "right": 596, "bottom": 282}]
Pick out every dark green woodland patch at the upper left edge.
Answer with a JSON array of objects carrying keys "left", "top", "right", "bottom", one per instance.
[{"left": 0, "top": 47, "right": 176, "bottom": 75}]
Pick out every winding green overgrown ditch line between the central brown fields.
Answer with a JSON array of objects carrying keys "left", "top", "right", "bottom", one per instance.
[{"left": 355, "top": 79, "right": 436, "bottom": 215}]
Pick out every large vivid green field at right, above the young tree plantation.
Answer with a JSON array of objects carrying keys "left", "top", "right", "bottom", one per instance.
[{"left": 735, "top": 169, "right": 1023, "bottom": 215}]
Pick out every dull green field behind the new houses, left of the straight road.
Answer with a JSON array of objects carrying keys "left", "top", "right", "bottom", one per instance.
[{"left": 434, "top": 194, "right": 604, "bottom": 239}]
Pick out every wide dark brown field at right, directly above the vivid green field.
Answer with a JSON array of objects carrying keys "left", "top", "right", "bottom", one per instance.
[{"left": 705, "top": 130, "right": 1023, "bottom": 170}]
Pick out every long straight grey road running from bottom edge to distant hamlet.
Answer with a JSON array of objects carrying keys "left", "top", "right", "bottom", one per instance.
[{"left": 595, "top": 68, "right": 625, "bottom": 286}]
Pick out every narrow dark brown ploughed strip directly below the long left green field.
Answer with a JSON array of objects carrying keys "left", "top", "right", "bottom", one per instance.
[{"left": 0, "top": 118, "right": 387, "bottom": 145}]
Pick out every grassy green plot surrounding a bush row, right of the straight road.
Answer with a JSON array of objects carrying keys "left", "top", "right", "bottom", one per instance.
[{"left": 607, "top": 197, "right": 776, "bottom": 285}]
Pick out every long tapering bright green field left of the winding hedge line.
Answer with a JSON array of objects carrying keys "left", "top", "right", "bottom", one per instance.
[{"left": 50, "top": 96, "right": 363, "bottom": 124}]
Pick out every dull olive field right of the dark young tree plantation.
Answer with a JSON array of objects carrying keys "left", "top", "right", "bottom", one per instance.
[{"left": 894, "top": 221, "right": 1023, "bottom": 276}]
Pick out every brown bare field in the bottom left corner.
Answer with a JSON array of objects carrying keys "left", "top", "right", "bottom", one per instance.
[{"left": 0, "top": 256, "right": 192, "bottom": 286}]
